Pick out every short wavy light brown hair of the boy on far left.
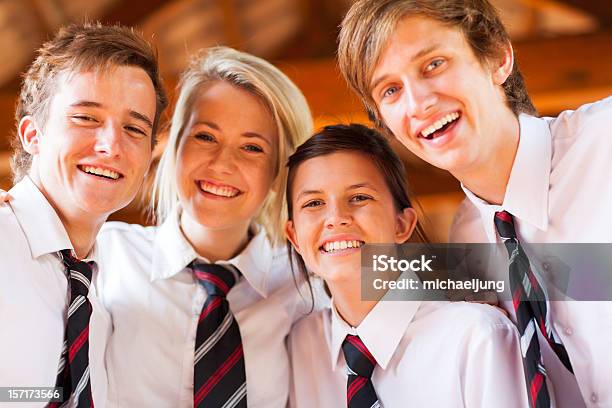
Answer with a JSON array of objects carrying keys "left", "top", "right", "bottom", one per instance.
[{"left": 11, "top": 22, "right": 168, "bottom": 182}]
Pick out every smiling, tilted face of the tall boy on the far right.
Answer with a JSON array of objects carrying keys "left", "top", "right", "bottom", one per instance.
[{"left": 371, "top": 16, "right": 514, "bottom": 175}]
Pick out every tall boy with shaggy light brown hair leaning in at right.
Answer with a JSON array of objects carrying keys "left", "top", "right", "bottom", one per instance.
[{"left": 338, "top": 0, "right": 612, "bottom": 407}]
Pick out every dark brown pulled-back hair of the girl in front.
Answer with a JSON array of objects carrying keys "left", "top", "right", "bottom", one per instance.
[{"left": 286, "top": 124, "right": 429, "bottom": 306}]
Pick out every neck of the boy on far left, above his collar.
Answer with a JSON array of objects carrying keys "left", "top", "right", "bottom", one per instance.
[{"left": 31, "top": 177, "right": 109, "bottom": 259}]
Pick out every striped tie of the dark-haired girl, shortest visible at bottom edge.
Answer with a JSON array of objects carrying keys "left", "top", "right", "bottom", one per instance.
[{"left": 342, "top": 334, "right": 381, "bottom": 408}]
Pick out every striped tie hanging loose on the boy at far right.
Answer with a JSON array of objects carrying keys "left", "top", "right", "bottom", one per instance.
[{"left": 495, "top": 211, "right": 573, "bottom": 408}]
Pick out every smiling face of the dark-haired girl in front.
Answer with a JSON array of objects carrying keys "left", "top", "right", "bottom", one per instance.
[{"left": 286, "top": 151, "right": 416, "bottom": 291}]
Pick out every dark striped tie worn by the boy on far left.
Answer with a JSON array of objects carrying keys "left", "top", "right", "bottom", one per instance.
[{"left": 48, "top": 249, "right": 94, "bottom": 408}]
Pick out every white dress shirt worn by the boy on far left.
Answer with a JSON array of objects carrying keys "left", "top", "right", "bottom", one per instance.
[{"left": 0, "top": 177, "right": 111, "bottom": 407}]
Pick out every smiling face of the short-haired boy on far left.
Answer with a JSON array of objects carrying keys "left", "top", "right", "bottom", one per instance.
[{"left": 19, "top": 66, "right": 155, "bottom": 219}]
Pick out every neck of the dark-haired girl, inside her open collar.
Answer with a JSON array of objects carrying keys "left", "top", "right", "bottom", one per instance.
[{"left": 327, "top": 279, "right": 378, "bottom": 327}]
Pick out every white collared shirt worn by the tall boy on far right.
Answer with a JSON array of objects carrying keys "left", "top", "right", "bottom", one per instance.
[{"left": 451, "top": 97, "right": 612, "bottom": 408}]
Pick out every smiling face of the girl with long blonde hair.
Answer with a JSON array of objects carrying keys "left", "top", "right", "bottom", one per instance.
[{"left": 176, "top": 81, "right": 278, "bottom": 233}]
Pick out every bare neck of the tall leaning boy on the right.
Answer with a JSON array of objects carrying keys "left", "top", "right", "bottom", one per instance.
[{"left": 451, "top": 109, "right": 520, "bottom": 205}]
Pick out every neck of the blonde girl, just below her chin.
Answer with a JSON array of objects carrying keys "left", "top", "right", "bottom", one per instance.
[{"left": 180, "top": 211, "right": 249, "bottom": 262}]
